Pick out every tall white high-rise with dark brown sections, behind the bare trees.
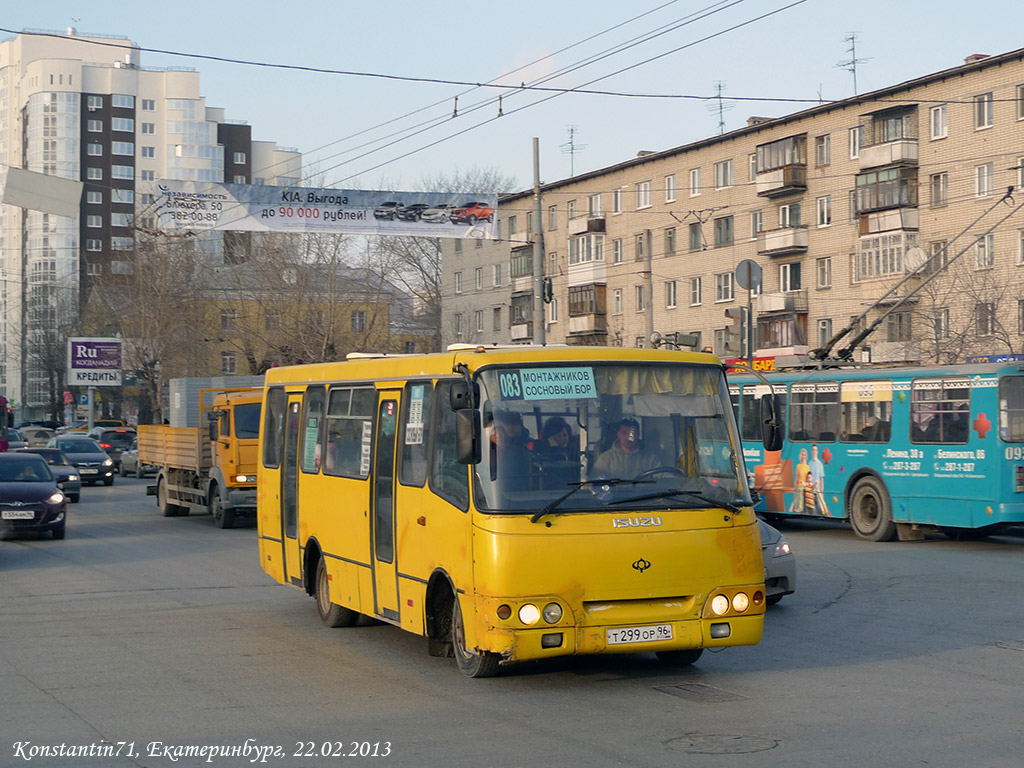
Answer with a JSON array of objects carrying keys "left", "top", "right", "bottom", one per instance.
[{"left": 0, "top": 29, "right": 302, "bottom": 415}]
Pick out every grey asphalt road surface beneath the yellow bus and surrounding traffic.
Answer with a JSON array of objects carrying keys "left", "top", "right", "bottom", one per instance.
[{"left": 0, "top": 478, "right": 1024, "bottom": 768}]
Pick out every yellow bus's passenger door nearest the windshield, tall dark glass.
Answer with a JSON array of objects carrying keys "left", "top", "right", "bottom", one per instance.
[{"left": 370, "top": 389, "right": 401, "bottom": 621}]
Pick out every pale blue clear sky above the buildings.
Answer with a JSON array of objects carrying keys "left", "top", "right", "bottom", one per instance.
[{"left": 6, "top": 0, "right": 1024, "bottom": 190}]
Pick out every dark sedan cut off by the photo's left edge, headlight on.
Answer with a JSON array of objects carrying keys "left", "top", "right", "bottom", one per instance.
[{"left": 0, "top": 451, "right": 68, "bottom": 539}]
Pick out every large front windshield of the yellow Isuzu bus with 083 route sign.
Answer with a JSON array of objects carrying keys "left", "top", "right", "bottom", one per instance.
[{"left": 474, "top": 362, "right": 751, "bottom": 513}]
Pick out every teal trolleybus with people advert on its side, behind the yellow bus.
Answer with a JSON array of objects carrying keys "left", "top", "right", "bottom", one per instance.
[{"left": 729, "top": 362, "right": 1024, "bottom": 541}]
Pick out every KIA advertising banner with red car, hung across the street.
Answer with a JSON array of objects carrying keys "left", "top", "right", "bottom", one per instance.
[{"left": 149, "top": 180, "right": 498, "bottom": 240}]
